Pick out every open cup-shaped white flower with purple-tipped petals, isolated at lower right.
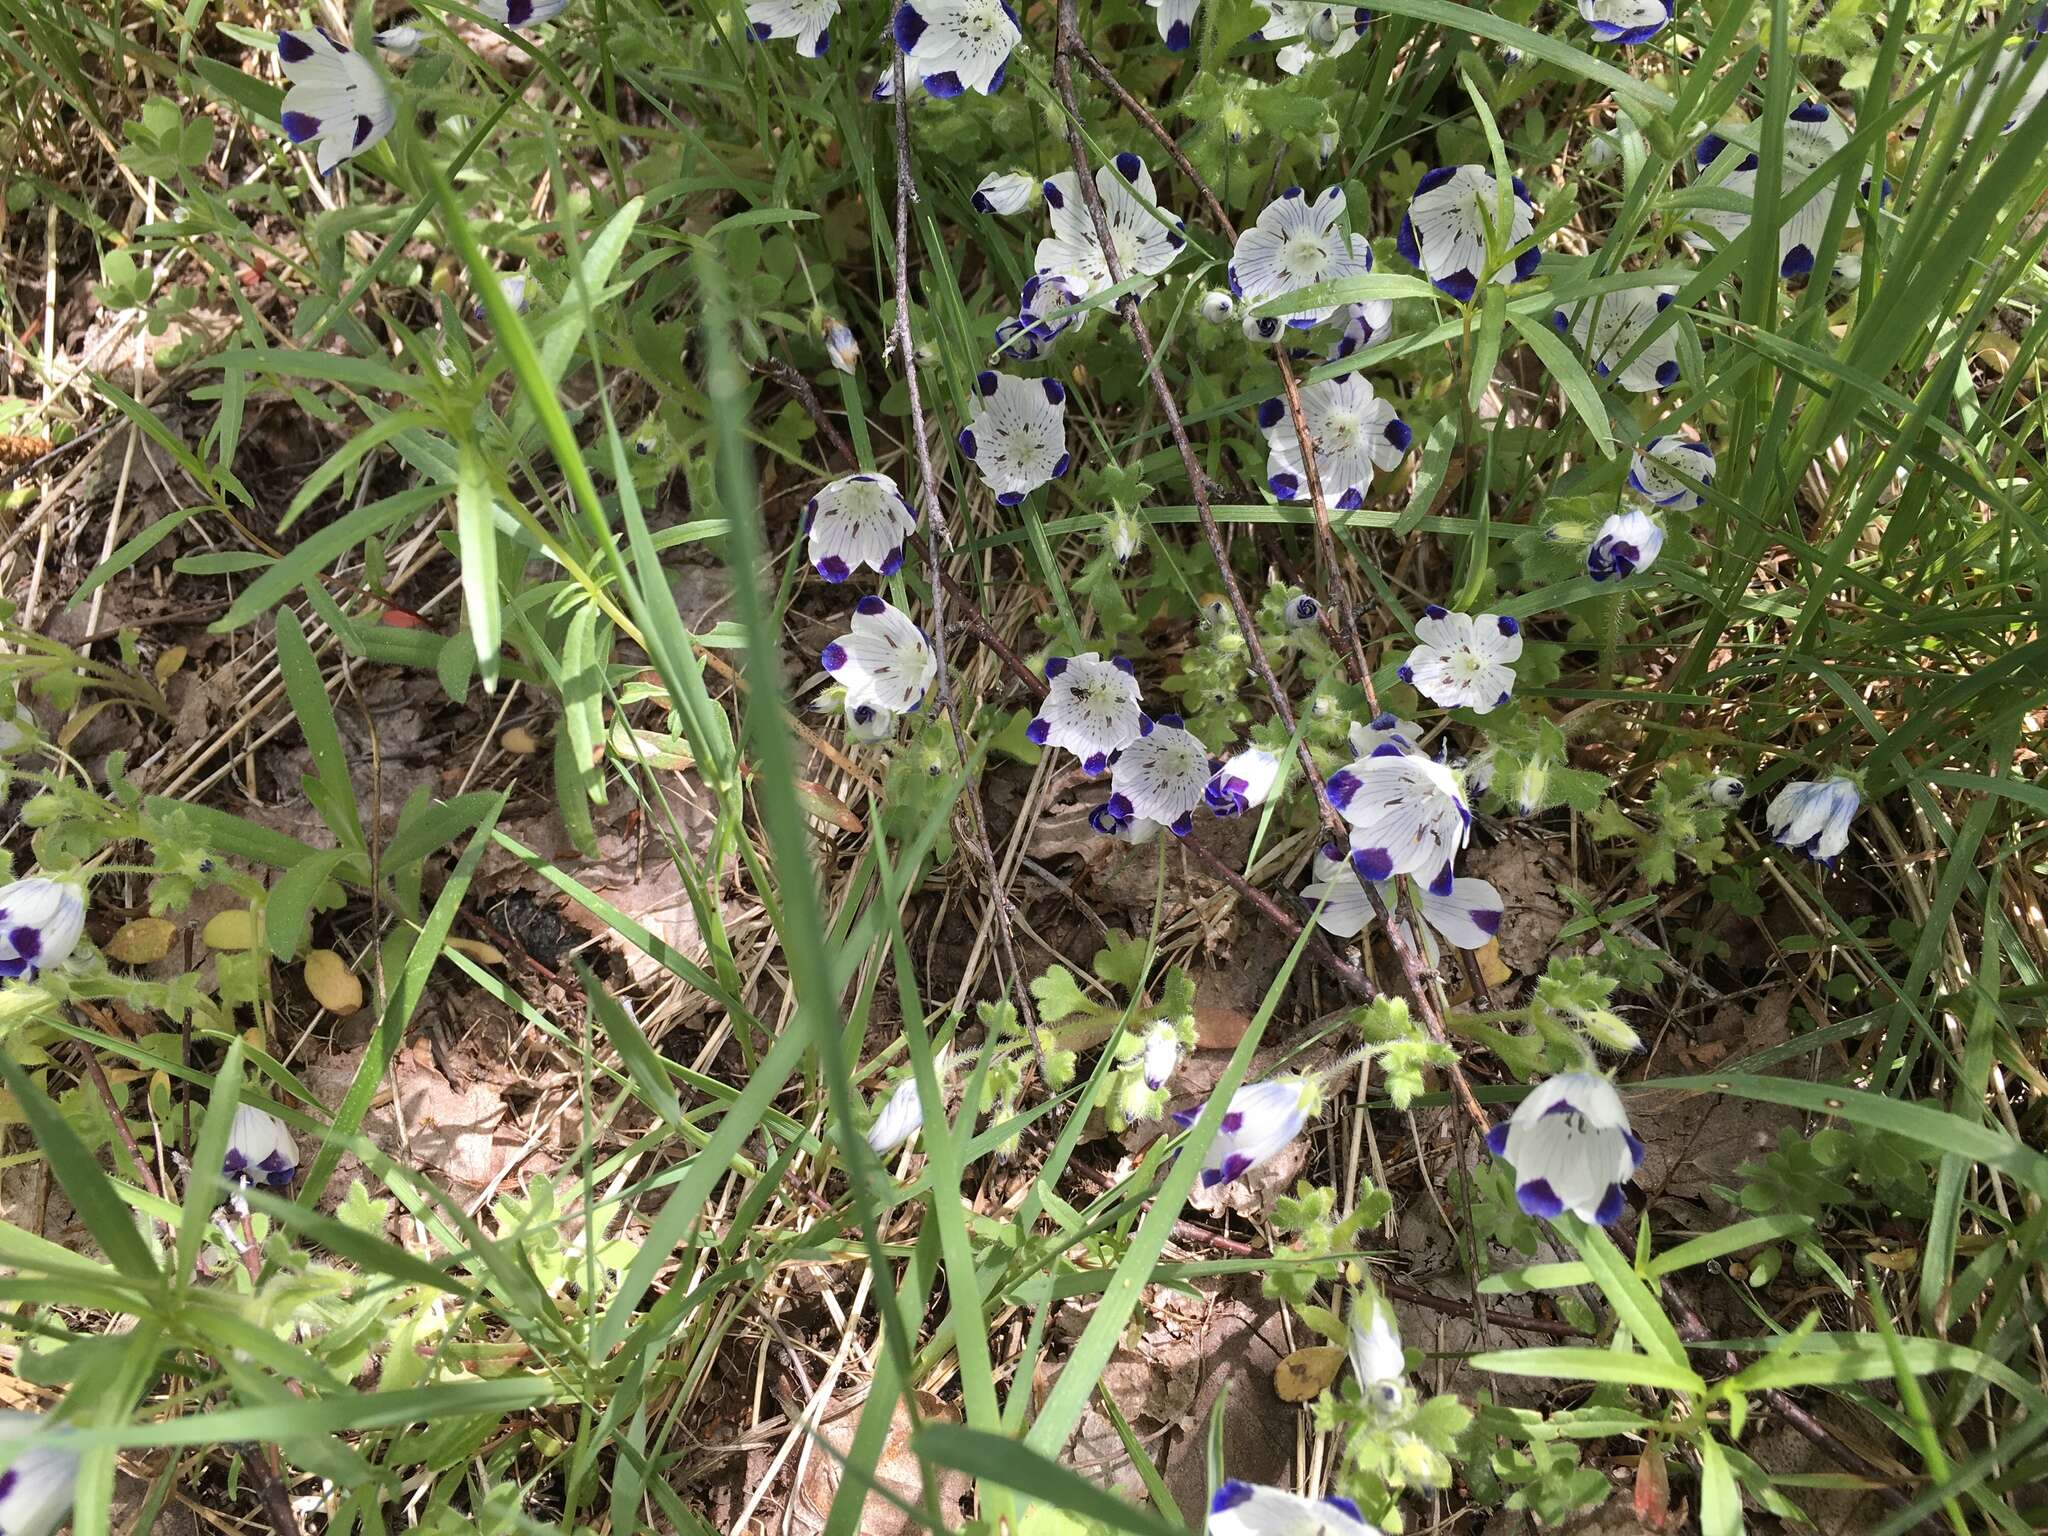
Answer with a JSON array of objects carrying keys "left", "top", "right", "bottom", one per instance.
[{"left": 1487, "top": 1071, "right": 1642, "bottom": 1227}]
